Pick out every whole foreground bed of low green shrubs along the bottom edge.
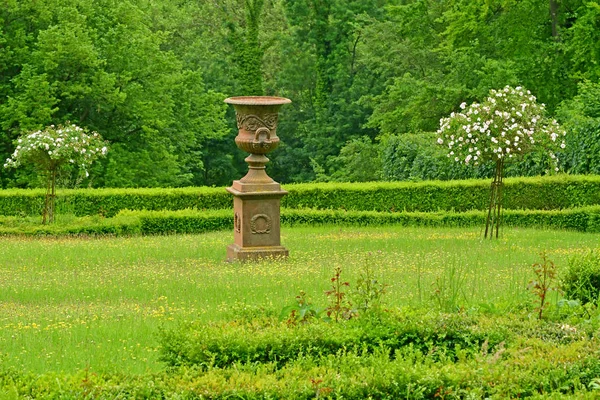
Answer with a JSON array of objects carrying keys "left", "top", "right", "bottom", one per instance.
[{"left": 0, "top": 311, "right": 600, "bottom": 399}]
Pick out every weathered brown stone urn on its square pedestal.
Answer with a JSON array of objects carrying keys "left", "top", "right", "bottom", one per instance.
[{"left": 225, "top": 96, "right": 291, "bottom": 261}]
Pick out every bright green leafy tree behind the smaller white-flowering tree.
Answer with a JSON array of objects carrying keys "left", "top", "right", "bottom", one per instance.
[{"left": 0, "top": 0, "right": 228, "bottom": 186}]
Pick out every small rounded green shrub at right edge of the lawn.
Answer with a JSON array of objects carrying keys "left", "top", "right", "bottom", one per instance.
[{"left": 562, "top": 249, "right": 600, "bottom": 305}]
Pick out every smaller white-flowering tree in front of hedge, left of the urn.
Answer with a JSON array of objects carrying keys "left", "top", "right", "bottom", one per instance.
[{"left": 4, "top": 124, "right": 108, "bottom": 224}]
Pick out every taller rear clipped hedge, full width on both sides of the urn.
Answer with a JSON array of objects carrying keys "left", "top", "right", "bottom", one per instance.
[{"left": 0, "top": 175, "right": 600, "bottom": 217}]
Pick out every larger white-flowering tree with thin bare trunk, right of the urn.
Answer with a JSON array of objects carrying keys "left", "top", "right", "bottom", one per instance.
[{"left": 437, "top": 86, "right": 565, "bottom": 238}]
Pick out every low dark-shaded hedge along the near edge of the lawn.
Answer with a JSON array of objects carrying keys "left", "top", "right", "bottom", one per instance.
[{"left": 159, "top": 308, "right": 600, "bottom": 370}]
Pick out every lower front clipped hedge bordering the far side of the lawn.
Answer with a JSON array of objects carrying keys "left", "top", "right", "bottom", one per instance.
[{"left": 0, "top": 206, "right": 600, "bottom": 235}]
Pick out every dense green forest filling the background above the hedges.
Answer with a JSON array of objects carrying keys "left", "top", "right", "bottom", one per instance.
[{"left": 0, "top": 0, "right": 600, "bottom": 188}]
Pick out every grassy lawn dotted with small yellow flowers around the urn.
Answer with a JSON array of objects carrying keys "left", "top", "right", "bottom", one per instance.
[{"left": 0, "top": 226, "right": 600, "bottom": 374}]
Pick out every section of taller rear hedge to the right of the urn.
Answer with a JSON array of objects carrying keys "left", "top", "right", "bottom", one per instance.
[{"left": 282, "top": 175, "right": 600, "bottom": 212}]
